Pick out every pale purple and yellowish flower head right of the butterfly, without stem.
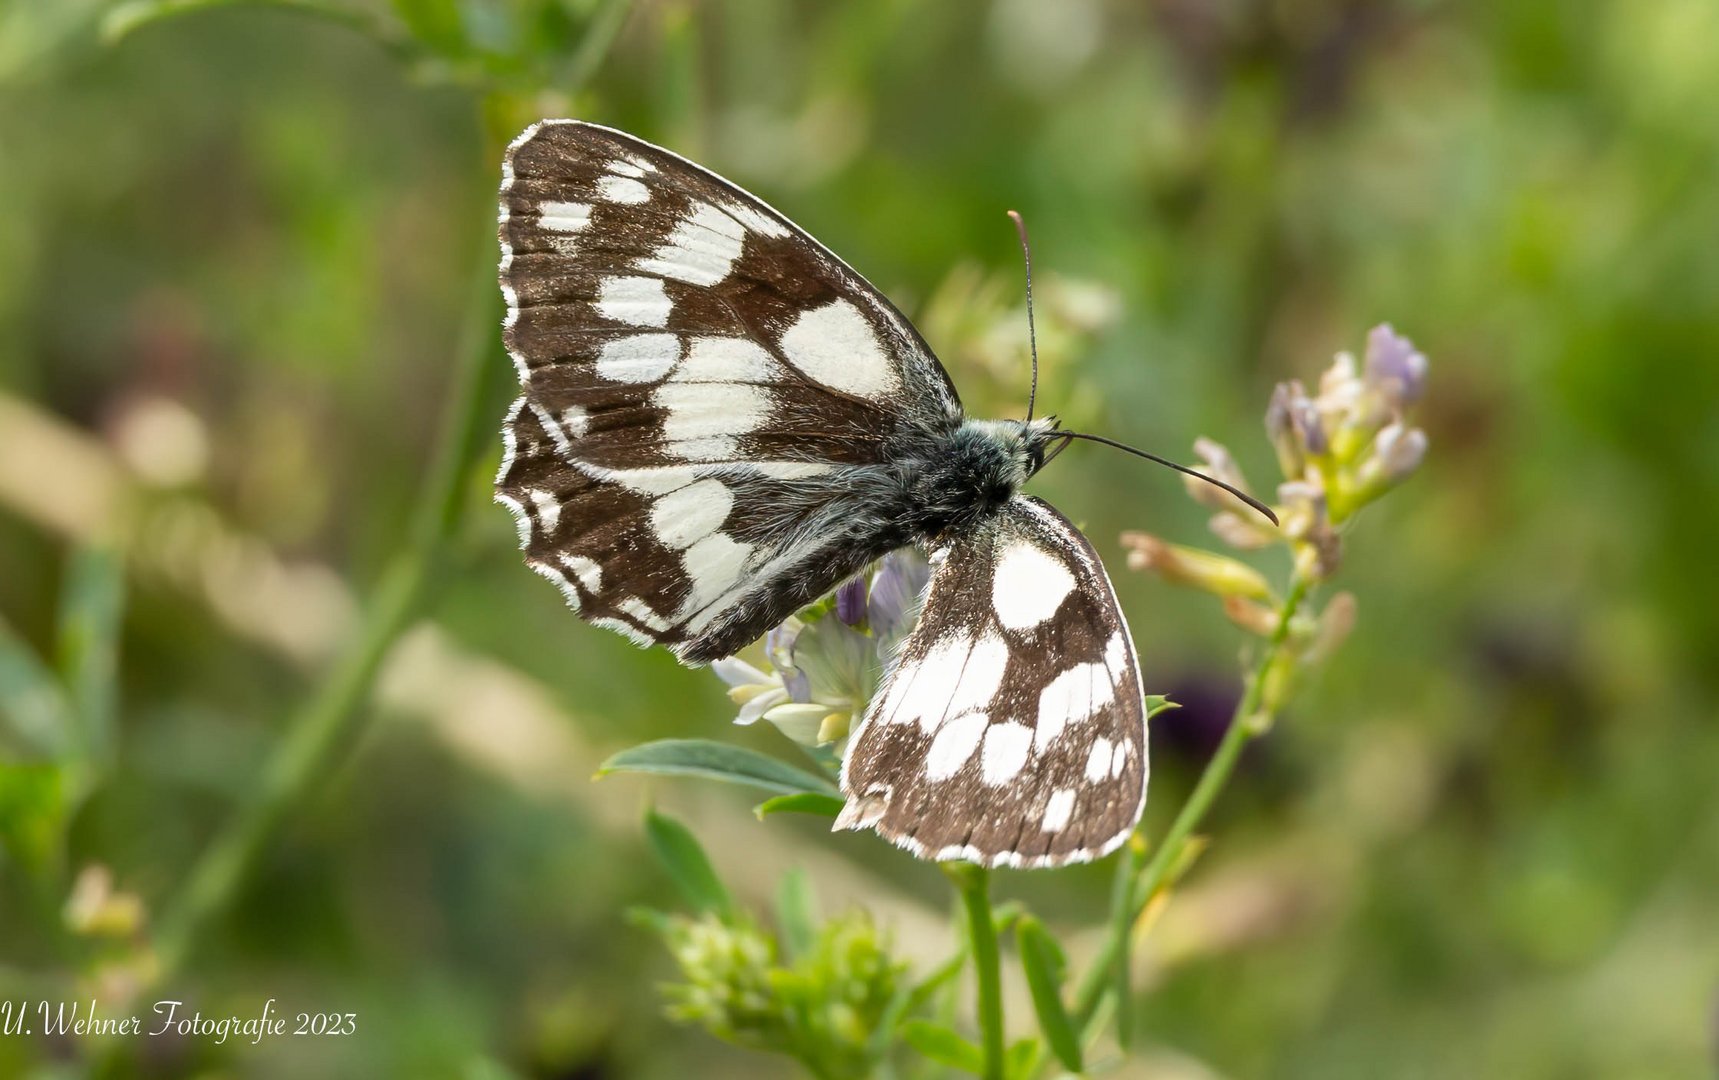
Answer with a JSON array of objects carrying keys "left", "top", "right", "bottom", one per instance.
[{"left": 1123, "top": 325, "right": 1427, "bottom": 712}]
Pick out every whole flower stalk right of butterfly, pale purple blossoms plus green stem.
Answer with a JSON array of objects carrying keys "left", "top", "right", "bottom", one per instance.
[{"left": 1074, "top": 325, "right": 1427, "bottom": 1047}]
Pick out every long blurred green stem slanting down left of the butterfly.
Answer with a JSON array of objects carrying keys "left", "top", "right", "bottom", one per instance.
[{"left": 155, "top": 179, "right": 499, "bottom": 979}]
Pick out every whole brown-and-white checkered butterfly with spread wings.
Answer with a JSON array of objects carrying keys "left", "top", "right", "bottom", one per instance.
[{"left": 495, "top": 120, "right": 1175, "bottom": 867}]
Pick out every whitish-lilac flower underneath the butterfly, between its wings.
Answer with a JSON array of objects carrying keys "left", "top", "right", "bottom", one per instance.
[{"left": 712, "top": 549, "right": 930, "bottom": 753}]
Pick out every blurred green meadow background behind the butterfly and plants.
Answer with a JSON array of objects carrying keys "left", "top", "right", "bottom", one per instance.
[{"left": 0, "top": 0, "right": 1719, "bottom": 1078}]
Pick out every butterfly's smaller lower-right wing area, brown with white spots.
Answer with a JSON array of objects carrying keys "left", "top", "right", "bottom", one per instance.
[{"left": 837, "top": 497, "right": 1147, "bottom": 867}]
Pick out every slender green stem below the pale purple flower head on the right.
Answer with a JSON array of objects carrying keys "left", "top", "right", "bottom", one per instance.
[{"left": 1074, "top": 573, "right": 1312, "bottom": 1039}]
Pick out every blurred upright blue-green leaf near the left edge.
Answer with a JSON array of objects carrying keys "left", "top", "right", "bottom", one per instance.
[{"left": 58, "top": 547, "right": 125, "bottom": 762}]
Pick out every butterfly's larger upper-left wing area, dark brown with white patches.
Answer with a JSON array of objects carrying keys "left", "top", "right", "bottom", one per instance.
[{"left": 497, "top": 120, "right": 961, "bottom": 660}]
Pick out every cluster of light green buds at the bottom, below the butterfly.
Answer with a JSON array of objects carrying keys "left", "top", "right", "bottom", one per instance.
[{"left": 658, "top": 911, "right": 908, "bottom": 1077}]
